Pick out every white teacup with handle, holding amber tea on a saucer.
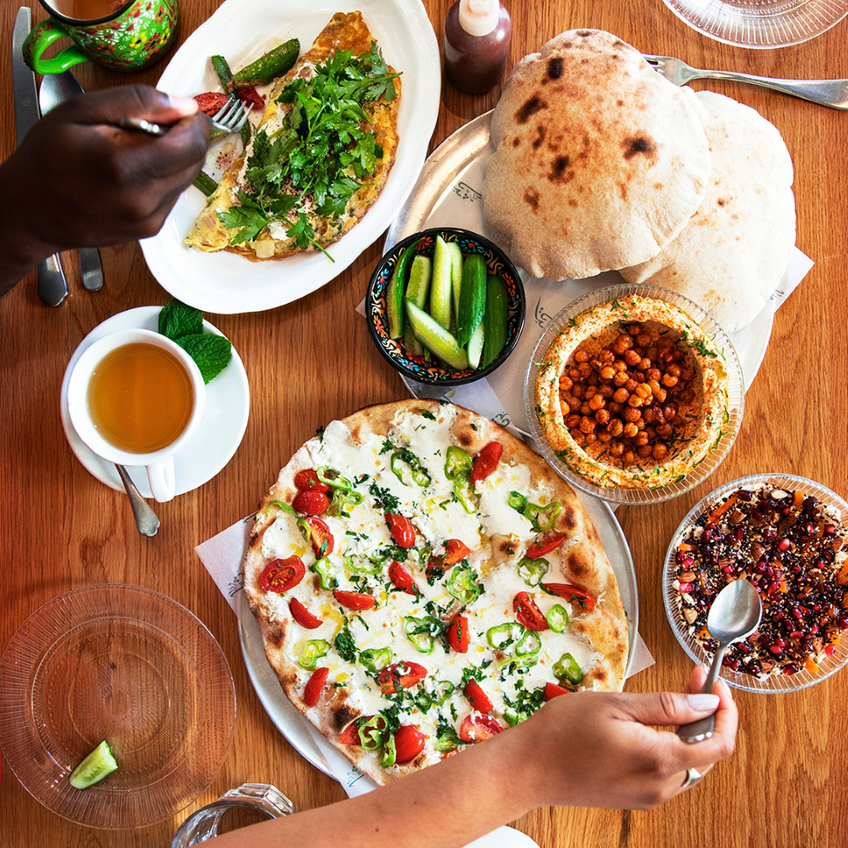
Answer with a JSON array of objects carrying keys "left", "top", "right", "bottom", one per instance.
[{"left": 68, "top": 330, "right": 206, "bottom": 503}]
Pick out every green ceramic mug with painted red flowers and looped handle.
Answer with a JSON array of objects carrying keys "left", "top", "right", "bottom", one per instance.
[{"left": 23, "top": 0, "right": 179, "bottom": 74}]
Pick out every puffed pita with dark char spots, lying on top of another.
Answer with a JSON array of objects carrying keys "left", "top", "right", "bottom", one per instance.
[{"left": 483, "top": 30, "right": 710, "bottom": 279}]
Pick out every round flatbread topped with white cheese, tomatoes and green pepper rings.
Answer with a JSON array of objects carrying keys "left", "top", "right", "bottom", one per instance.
[{"left": 243, "top": 400, "right": 628, "bottom": 783}]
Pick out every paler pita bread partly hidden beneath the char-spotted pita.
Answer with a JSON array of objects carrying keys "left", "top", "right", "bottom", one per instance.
[{"left": 621, "top": 91, "right": 795, "bottom": 332}]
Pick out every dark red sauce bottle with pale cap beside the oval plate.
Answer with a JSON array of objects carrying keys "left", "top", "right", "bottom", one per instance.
[{"left": 445, "top": 0, "right": 512, "bottom": 94}]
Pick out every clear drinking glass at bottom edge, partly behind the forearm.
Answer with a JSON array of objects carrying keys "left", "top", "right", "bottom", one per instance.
[{"left": 171, "top": 783, "right": 294, "bottom": 848}]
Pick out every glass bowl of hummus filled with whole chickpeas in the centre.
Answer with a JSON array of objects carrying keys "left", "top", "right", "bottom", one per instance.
[{"left": 524, "top": 284, "right": 745, "bottom": 504}]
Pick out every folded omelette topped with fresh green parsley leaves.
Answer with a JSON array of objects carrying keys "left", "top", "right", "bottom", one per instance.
[{"left": 186, "top": 12, "right": 401, "bottom": 262}]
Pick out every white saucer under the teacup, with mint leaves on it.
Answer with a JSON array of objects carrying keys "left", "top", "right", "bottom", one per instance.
[{"left": 60, "top": 306, "right": 250, "bottom": 498}]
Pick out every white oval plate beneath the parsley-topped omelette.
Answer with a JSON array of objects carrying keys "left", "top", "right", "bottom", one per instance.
[{"left": 141, "top": 0, "right": 441, "bottom": 314}]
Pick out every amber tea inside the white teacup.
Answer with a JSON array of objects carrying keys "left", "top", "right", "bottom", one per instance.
[{"left": 86, "top": 342, "right": 194, "bottom": 453}]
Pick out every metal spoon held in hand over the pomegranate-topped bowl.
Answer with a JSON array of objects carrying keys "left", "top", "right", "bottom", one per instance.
[{"left": 677, "top": 580, "right": 763, "bottom": 742}]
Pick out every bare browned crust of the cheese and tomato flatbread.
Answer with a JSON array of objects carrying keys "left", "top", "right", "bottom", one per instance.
[{"left": 243, "top": 399, "right": 628, "bottom": 784}]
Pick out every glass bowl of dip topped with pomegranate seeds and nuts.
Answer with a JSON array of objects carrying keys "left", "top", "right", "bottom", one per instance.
[{"left": 663, "top": 473, "right": 848, "bottom": 692}]
